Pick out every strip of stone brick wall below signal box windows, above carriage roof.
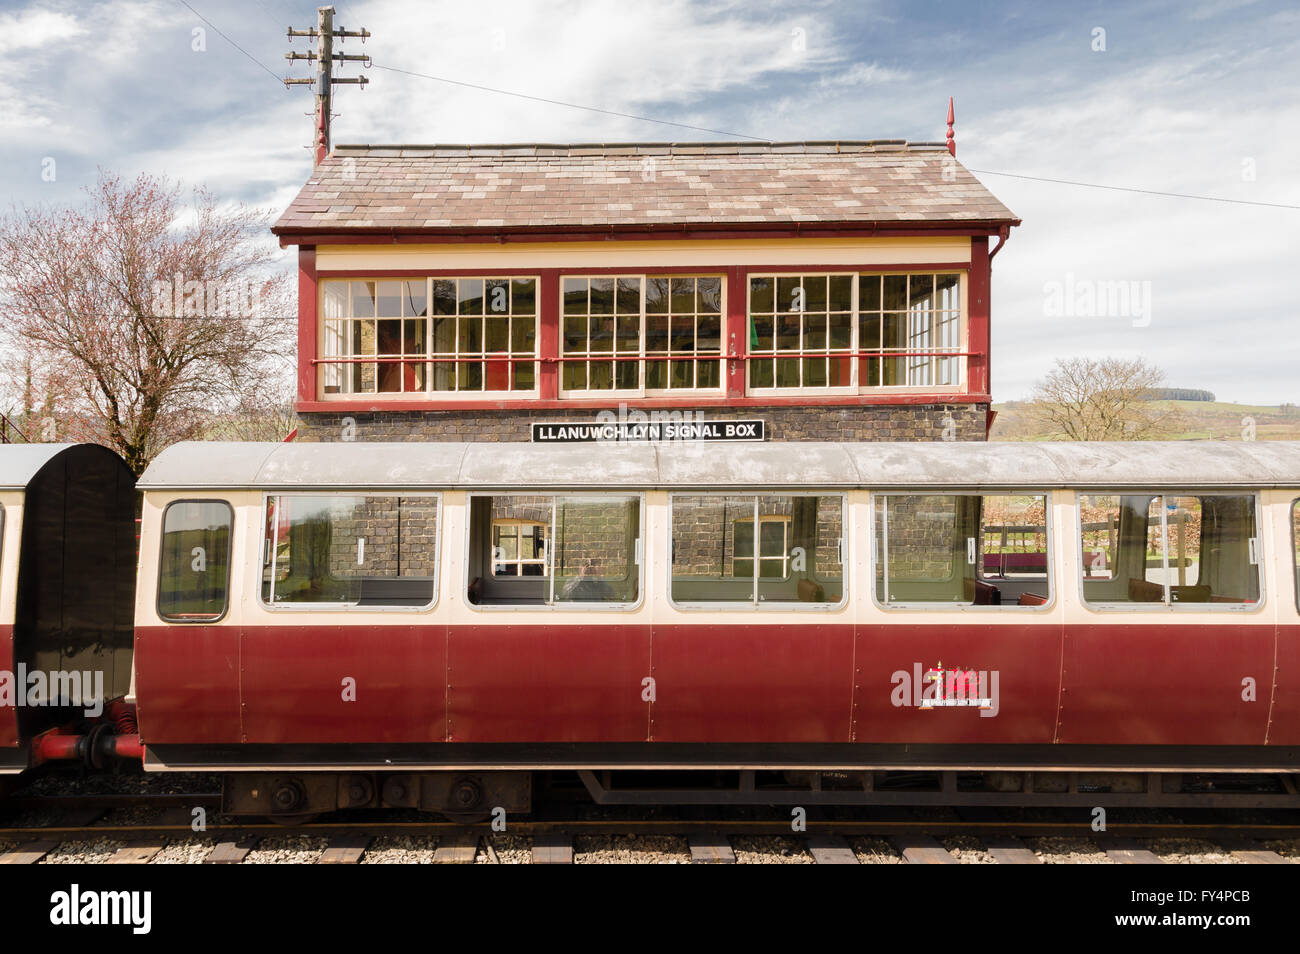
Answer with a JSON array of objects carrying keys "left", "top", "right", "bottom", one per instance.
[{"left": 298, "top": 404, "right": 988, "bottom": 442}]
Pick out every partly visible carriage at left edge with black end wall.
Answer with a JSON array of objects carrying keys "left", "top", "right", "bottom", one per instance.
[{"left": 0, "top": 445, "right": 140, "bottom": 775}]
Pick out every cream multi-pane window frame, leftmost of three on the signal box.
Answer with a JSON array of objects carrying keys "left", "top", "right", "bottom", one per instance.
[{"left": 316, "top": 269, "right": 542, "bottom": 403}]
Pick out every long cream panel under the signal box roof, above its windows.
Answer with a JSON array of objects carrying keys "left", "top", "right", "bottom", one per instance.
[{"left": 316, "top": 235, "right": 971, "bottom": 272}]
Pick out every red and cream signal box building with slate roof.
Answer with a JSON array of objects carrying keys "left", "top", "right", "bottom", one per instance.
[{"left": 273, "top": 140, "right": 1019, "bottom": 441}]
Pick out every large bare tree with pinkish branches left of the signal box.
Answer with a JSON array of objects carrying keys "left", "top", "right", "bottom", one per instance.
[{"left": 0, "top": 172, "right": 294, "bottom": 473}]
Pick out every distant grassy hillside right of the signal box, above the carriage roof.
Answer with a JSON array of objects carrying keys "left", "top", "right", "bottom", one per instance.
[{"left": 989, "top": 400, "right": 1300, "bottom": 441}]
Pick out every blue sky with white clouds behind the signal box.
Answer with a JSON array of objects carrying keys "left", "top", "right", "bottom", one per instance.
[{"left": 0, "top": 0, "right": 1300, "bottom": 404}]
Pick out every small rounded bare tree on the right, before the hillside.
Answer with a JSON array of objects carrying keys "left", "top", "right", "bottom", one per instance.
[{"left": 1030, "top": 357, "right": 1175, "bottom": 441}]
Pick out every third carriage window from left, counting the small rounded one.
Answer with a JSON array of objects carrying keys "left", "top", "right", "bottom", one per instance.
[{"left": 468, "top": 494, "right": 641, "bottom": 606}]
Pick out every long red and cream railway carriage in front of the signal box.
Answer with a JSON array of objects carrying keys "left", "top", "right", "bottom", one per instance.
[{"left": 134, "top": 442, "right": 1300, "bottom": 816}]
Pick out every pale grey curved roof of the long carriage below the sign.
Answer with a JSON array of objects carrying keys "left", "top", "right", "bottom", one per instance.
[{"left": 131, "top": 441, "right": 1300, "bottom": 490}]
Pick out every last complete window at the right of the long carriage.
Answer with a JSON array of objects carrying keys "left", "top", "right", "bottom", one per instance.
[{"left": 1079, "top": 494, "right": 1260, "bottom": 608}]
